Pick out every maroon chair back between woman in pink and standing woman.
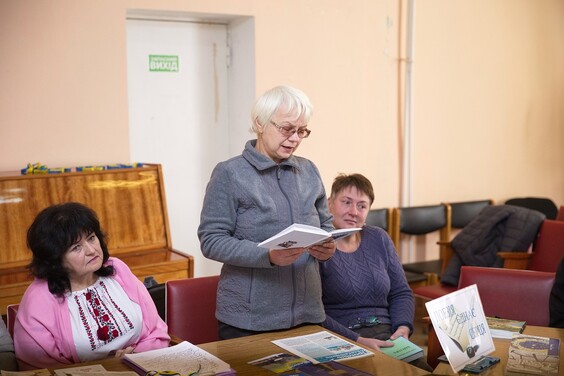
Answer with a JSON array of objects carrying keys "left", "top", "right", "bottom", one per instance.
[{"left": 165, "top": 276, "right": 219, "bottom": 345}]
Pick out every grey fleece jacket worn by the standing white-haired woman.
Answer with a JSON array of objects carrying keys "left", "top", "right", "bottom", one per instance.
[{"left": 195, "top": 140, "right": 333, "bottom": 331}]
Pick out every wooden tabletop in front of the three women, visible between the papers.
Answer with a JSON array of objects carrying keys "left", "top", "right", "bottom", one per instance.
[{"left": 51, "top": 325, "right": 428, "bottom": 376}]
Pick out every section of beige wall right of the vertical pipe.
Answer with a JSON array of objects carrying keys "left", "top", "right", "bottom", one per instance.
[{"left": 414, "top": 0, "right": 564, "bottom": 205}]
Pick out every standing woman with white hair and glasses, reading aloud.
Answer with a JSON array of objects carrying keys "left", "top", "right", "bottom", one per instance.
[{"left": 198, "top": 86, "right": 335, "bottom": 339}]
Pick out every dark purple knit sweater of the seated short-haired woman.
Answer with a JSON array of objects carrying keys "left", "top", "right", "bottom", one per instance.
[{"left": 320, "top": 226, "right": 414, "bottom": 341}]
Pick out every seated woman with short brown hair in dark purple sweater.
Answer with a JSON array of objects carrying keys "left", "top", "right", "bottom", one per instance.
[{"left": 320, "top": 174, "right": 432, "bottom": 371}]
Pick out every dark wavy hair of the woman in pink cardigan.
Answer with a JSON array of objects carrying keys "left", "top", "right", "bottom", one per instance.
[{"left": 27, "top": 202, "right": 114, "bottom": 297}]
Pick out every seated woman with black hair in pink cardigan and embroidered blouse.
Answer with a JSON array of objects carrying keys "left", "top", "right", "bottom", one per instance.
[{"left": 14, "top": 202, "right": 170, "bottom": 370}]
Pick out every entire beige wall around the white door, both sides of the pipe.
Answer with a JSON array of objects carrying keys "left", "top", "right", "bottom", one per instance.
[{"left": 0, "top": 0, "right": 564, "bottom": 262}]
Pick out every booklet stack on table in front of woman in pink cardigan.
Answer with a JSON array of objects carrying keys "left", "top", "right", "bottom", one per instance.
[{"left": 122, "top": 341, "right": 236, "bottom": 376}]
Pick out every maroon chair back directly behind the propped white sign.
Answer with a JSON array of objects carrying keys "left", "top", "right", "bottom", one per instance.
[{"left": 458, "top": 266, "right": 555, "bottom": 326}]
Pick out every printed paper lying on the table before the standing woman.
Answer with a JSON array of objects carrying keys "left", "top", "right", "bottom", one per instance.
[{"left": 272, "top": 331, "right": 374, "bottom": 363}]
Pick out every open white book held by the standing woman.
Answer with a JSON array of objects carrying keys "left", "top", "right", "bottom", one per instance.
[{"left": 258, "top": 223, "right": 362, "bottom": 249}]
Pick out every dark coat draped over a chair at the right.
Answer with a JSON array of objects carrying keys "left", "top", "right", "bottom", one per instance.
[{"left": 441, "top": 205, "right": 545, "bottom": 286}]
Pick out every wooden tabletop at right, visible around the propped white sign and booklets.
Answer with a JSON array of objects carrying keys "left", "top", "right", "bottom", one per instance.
[{"left": 433, "top": 325, "right": 564, "bottom": 376}]
